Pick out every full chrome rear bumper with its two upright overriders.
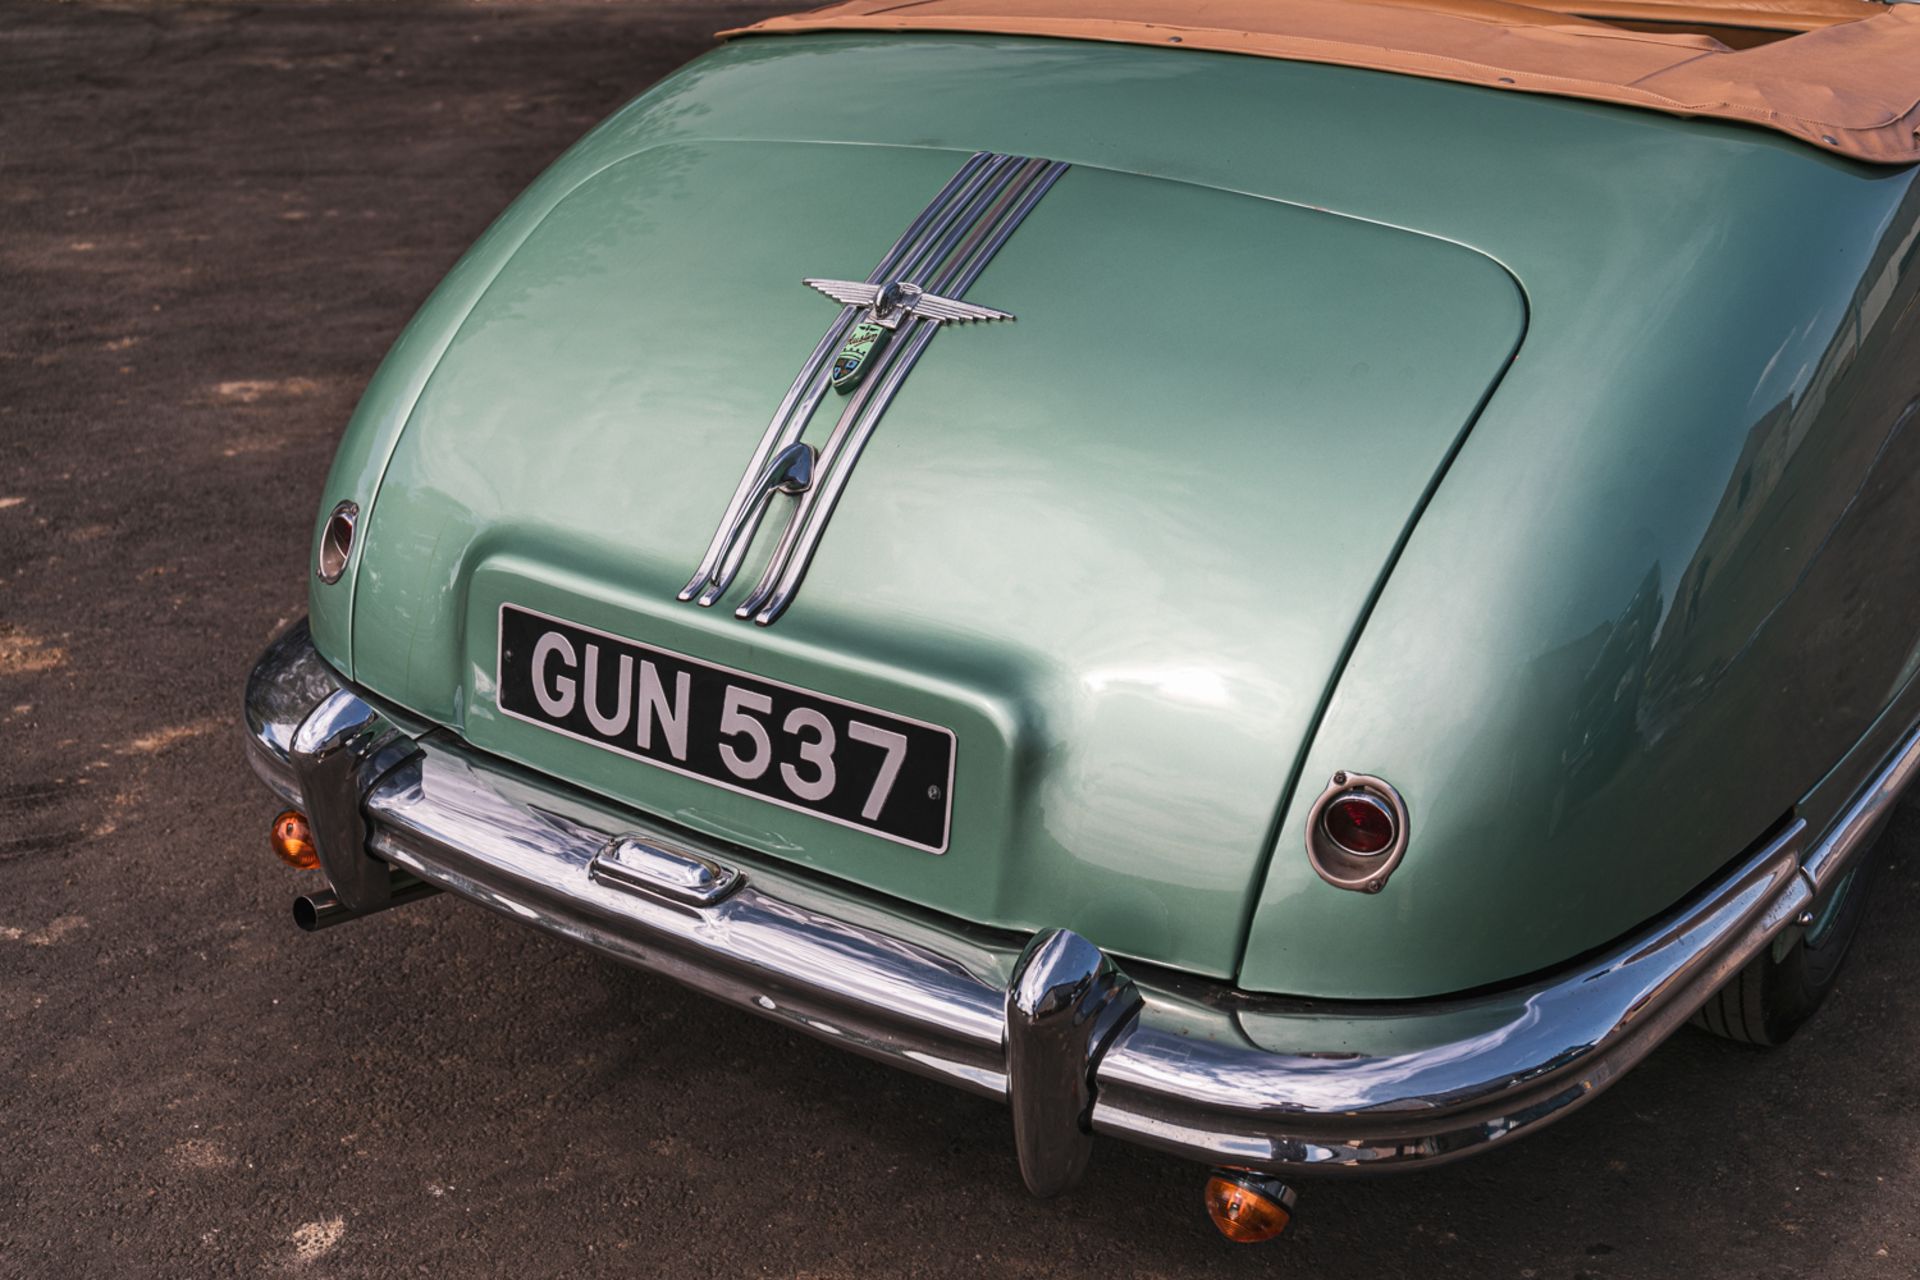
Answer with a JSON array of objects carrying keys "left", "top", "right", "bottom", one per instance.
[{"left": 246, "top": 624, "right": 1920, "bottom": 1194}]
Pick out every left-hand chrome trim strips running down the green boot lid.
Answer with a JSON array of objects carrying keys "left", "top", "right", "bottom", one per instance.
[{"left": 680, "top": 152, "right": 1006, "bottom": 604}]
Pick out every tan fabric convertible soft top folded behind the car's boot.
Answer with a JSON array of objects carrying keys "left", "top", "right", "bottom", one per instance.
[{"left": 722, "top": 0, "right": 1920, "bottom": 165}]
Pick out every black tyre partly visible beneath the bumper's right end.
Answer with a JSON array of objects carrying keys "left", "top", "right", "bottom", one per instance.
[{"left": 1693, "top": 837, "right": 1884, "bottom": 1046}]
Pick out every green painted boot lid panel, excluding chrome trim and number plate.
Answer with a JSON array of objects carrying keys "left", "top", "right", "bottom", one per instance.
[{"left": 341, "top": 142, "right": 1523, "bottom": 975}]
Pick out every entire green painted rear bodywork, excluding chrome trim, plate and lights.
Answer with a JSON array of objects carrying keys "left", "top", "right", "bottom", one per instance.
[{"left": 313, "top": 25, "right": 1920, "bottom": 998}]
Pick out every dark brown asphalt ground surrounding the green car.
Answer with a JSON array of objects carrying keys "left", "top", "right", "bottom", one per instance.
[{"left": 0, "top": 0, "right": 1920, "bottom": 1280}]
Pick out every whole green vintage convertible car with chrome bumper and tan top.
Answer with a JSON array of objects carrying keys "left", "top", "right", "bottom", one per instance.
[{"left": 246, "top": 0, "right": 1920, "bottom": 1238}]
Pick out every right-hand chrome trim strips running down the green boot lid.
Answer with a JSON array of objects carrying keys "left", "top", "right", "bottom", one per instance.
[{"left": 733, "top": 159, "right": 1068, "bottom": 628}]
